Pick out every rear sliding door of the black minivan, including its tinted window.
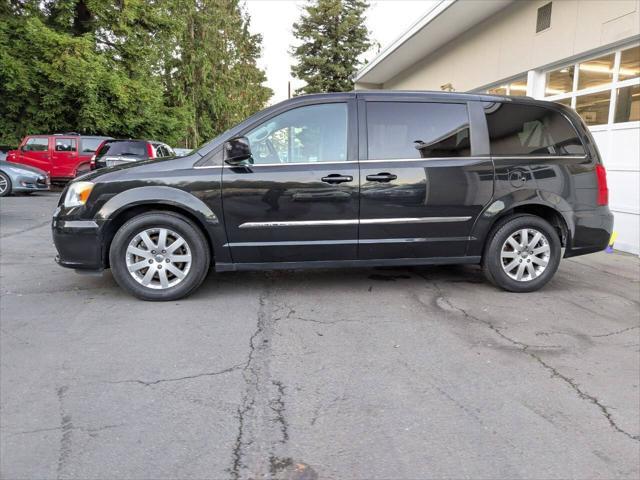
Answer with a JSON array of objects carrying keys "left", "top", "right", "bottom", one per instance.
[{"left": 359, "top": 100, "right": 493, "bottom": 260}]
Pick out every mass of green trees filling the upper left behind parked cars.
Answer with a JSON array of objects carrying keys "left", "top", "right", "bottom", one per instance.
[{"left": 0, "top": 0, "right": 271, "bottom": 147}]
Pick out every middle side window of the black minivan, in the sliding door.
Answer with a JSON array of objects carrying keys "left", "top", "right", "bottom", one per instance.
[{"left": 367, "top": 102, "right": 470, "bottom": 160}]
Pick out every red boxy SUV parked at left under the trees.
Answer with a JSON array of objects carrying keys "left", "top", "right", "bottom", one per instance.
[{"left": 7, "top": 133, "right": 109, "bottom": 182}]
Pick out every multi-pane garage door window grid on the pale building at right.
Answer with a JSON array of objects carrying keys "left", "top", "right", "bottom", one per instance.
[{"left": 545, "top": 46, "right": 640, "bottom": 126}]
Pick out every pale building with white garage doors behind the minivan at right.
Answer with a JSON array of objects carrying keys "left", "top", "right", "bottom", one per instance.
[{"left": 356, "top": 0, "right": 640, "bottom": 254}]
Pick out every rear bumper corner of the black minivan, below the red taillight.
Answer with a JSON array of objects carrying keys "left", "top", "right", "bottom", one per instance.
[{"left": 564, "top": 207, "right": 613, "bottom": 258}]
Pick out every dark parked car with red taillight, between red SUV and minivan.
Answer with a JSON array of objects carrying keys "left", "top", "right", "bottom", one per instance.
[{"left": 90, "top": 139, "right": 176, "bottom": 170}]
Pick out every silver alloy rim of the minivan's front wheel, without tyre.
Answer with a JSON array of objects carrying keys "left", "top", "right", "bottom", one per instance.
[{"left": 126, "top": 228, "right": 191, "bottom": 290}]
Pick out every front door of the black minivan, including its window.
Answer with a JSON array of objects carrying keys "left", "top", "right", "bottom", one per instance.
[{"left": 222, "top": 100, "right": 359, "bottom": 263}]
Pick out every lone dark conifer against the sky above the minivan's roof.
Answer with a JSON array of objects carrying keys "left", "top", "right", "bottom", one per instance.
[{"left": 291, "top": 0, "right": 372, "bottom": 93}]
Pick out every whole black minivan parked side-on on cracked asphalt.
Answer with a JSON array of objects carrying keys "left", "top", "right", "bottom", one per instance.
[{"left": 52, "top": 91, "right": 613, "bottom": 300}]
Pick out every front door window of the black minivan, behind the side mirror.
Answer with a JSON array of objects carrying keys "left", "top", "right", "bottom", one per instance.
[{"left": 246, "top": 103, "right": 347, "bottom": 165}]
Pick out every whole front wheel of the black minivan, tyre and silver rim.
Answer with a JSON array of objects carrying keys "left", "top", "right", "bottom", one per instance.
[{"left": 109, "top": 212, "right": 210, "bottom": 301}]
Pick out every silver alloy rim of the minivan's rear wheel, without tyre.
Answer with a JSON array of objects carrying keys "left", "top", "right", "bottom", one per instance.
[{"left": 500, "top": 228, "right": 551, "bottom": 282}]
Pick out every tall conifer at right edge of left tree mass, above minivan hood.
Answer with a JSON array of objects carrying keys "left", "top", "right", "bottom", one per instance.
[{"left": 164, "top": 0, "right": 272, "bottom": 147}]
